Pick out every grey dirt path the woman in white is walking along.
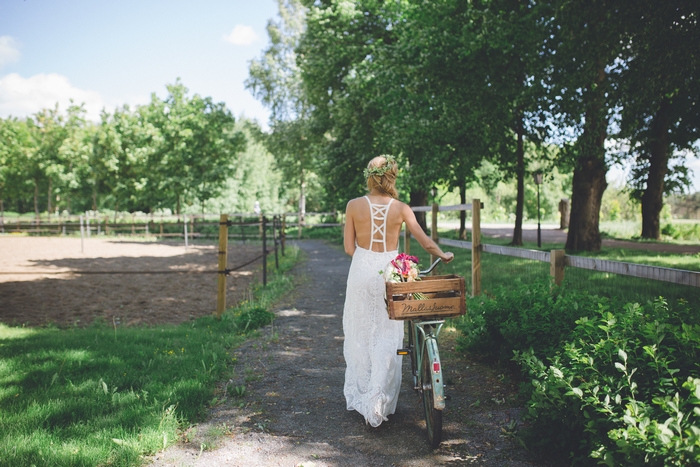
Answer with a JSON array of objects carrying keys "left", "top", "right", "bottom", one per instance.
[{"left": 146, "top": 240, "right": 542, "bottom": 467}]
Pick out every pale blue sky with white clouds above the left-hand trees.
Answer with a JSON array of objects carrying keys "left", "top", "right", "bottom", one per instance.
[{"left": 0, "top": 0, "right": 278, "bottom": 128}]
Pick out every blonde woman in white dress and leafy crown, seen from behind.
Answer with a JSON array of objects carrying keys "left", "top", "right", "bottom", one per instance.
[{"left": 343, "top": 156, "right": 454, "bottom": 427}]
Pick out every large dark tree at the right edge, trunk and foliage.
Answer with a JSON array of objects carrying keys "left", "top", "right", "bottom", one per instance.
[{"left": 618, "top": 0, "right": 700, "bottom": 240}]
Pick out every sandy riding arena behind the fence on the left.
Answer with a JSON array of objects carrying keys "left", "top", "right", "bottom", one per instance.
[{"left": 0, "top": 236, "right": 262, "bottom": 327}]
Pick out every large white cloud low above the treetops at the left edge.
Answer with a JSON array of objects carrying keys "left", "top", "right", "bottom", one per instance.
[{"left": 0, "top": 73, "right": 105, "bottom": 121}]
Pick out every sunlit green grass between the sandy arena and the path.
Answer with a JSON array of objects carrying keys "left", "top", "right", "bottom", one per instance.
[{"left": 0, "top": 248, "right": 298, "bottom": 467}]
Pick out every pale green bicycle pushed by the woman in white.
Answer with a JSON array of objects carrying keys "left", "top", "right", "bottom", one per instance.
[{"left": 389, "top": 258, "right": 464, "bottom": 449}]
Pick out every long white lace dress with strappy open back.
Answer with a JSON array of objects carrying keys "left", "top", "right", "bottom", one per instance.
[{"left": 343, "top": 197, "right": 403, "bottom": 427}]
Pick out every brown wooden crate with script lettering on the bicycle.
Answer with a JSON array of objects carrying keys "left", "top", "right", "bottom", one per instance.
[{"left": 386, "top": 275, "right": 467, "bottom": 320}]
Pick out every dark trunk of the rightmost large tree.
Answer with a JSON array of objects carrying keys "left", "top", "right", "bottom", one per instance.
[{"left": 641, "top": 98, "right": 670, "bottom": 240}]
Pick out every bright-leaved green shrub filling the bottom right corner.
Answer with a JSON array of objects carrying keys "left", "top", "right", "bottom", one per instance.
[{"left": 514, "top": 299, "right": 700, "bottom": 466}]
